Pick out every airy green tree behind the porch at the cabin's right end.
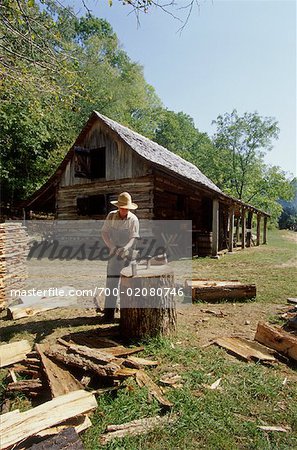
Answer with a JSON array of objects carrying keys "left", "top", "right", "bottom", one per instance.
[{"left": 206, "top": 110, "right": 293, "bottom": 223}]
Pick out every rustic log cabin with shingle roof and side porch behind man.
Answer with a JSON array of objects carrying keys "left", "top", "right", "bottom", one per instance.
[{"left": 23, "top": 111, "right": 269, "bottom": 257}]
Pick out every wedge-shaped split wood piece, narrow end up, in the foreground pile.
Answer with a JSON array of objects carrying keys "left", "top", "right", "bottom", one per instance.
[{"left": 36, "top": 344, "right": 83, "bottom": 398}]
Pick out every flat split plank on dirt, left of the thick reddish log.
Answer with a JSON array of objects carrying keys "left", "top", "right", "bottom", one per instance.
[{"left": 212, "top": 337, "right": 275, "bottom": 362}]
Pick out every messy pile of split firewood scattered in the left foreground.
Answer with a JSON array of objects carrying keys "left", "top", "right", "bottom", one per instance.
[{"left": 0, "top": 326, "right": 173, "bottom": 450}]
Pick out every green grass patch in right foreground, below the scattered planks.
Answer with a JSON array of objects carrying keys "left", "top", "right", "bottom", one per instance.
[{"left": 84, "top": 339, "right": 297, "bottom": 450}]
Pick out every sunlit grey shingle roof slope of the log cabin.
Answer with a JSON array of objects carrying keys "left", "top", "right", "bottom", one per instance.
[{"left": 95, "top": 111, "right": 222, "bottom": 193}]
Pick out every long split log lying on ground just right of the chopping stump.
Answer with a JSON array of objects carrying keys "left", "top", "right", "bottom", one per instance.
[{"left": 185, "top": 279, "right": 257, "bottom": 303}]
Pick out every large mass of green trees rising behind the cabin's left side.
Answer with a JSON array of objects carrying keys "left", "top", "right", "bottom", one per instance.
[{"left": 0, "top": 7, "right": 161, "bottom": 205}]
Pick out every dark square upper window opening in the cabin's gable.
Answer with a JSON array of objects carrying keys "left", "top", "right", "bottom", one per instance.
[{"left": 74, "top": 147, "right": 106, "bottom": 179}]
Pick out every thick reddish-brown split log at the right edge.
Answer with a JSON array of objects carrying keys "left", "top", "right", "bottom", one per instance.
[{"left": 255, "top": 322, "right": 297, "bottom": 361}]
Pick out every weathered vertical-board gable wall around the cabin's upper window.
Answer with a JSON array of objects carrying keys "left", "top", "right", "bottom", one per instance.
[{"left": 60, "top": 121, "right": 152, "bottom": 187}]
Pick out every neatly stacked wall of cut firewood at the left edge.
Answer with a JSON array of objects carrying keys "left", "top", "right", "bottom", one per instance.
[{"left": 0, "top": 223, "right": 28, "bottom": 310}]
